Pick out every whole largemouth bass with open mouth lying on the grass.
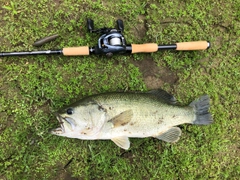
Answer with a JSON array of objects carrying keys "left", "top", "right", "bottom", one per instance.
[{"left": 51, "top": 89, "right": 213, "bottom": 150}]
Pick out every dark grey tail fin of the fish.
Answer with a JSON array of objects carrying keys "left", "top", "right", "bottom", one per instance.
[{"left": 189, "top": 95, "right": 213, "bottom": 125}]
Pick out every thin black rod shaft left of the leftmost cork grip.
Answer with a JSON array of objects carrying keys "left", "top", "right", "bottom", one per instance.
[{"left": 0, "top": 50, "right": 62, "bottom": 57}]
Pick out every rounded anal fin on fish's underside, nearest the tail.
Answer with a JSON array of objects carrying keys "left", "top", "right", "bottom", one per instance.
[{"left": 155, "top": 127, "right": 182, "bottom": 142}]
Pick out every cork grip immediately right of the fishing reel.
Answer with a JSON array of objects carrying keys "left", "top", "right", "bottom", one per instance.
[{"left": 131, "top": 43, "right": 158, "bottom": 53}]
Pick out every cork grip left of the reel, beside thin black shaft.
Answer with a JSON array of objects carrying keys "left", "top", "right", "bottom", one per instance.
[{"left": 63, "top": 46, "right": 89, "bottom": 56}]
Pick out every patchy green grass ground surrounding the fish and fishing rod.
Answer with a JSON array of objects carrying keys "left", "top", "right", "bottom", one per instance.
[{"left": 0, "top": 0, "right": 240, "bottom": 180}]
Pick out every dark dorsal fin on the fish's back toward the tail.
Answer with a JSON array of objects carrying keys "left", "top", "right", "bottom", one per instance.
[{"left": 147, "top": 89, "right": 177, "bottom": 104}]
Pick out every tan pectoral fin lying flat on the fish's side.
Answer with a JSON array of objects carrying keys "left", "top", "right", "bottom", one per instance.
[{"left": 108, "top": 109, "right": 133, "bottom": 127}]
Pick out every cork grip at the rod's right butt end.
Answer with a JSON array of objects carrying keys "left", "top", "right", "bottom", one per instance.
[{"left": 176, "top": 41, "right": 210, "bottom": 51}]
